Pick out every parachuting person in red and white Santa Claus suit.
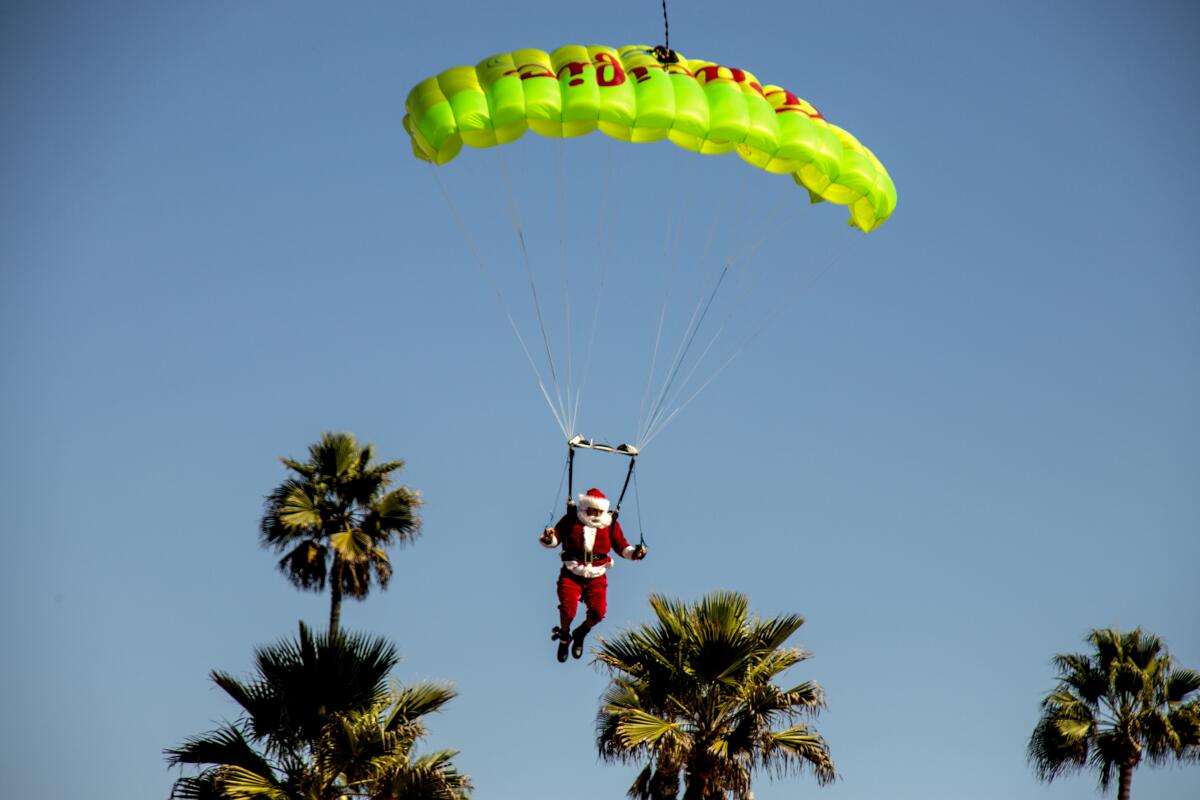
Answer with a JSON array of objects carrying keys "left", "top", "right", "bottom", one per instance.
[{"left": 540, "top": 488, "right": 646, "bottom": 661}]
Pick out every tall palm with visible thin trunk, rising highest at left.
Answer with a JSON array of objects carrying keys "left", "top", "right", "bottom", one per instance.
[{"left": 262, "top": 433, "right": 421, "bottom": 633}]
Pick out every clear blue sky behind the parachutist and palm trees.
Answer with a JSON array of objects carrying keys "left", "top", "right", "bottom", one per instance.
[{"left": 0, "top": 0, "right": 1200, "bottom": 800}]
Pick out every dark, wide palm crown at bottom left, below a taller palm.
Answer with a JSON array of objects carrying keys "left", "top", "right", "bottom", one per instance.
[{"left": 166, "top": 622, "right": 472, "bottom": 800}]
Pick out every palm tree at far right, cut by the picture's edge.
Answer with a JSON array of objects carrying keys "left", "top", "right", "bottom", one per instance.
[{"left": 1028, "top": 628, "right": 1200, "bottom": 800}]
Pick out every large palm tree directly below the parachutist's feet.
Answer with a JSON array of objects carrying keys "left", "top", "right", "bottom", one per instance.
[{"left": 596, "top": 591, "right": 836, "bottom": 800}]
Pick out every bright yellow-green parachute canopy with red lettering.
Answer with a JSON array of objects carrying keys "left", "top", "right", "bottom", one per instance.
[{"left": 404, "top": 44, "right": 896, "bottom": 231}]
